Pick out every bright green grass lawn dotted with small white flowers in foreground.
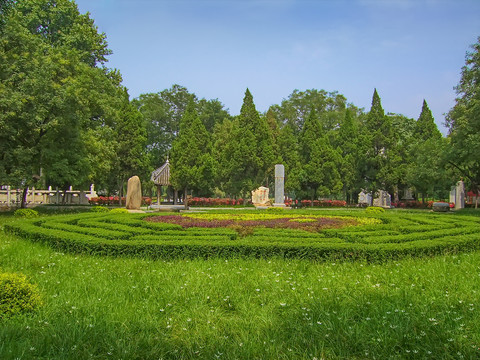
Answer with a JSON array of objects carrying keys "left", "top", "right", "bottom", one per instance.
[{"left": 0, "top": 213, "right": 480, "bottom": 359}]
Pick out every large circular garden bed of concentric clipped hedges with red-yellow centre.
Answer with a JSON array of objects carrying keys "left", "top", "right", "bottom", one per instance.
[{"left": 5, "top": 210, "right": 480, "bottom": 261}]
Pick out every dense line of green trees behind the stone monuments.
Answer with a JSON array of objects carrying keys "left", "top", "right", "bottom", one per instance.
[{"left": 0, "top": 0, "right": 480, "bottom": 202}]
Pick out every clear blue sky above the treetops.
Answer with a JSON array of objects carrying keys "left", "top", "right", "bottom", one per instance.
[{"left": 76, "top": 0, "right": 480, "bottom": 133}]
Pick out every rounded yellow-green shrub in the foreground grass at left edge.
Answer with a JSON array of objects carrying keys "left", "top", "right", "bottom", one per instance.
[{"left": 0, "top": 273, "right": 42, "bottom": 319}]
